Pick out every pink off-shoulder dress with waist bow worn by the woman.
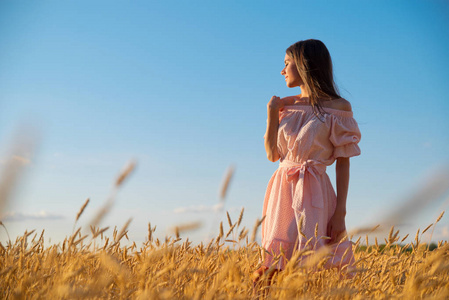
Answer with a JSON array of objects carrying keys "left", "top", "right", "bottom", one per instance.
[{"left": 262, "top": 99, "right": 361, "bottom": 269}]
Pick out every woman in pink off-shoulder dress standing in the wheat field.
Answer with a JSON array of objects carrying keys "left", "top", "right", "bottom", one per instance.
[{"left": 253, "top": 40, "right": 361, "bottom": 282}]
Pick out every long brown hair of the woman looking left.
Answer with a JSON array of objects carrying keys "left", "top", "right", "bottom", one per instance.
[{"left": 286, "top": 39, "right": 340, "bottom": 114}]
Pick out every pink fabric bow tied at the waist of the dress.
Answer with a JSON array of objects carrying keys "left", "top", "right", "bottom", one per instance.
[{"left": 279, "top": 159, "right": 326, "bottom": 210}]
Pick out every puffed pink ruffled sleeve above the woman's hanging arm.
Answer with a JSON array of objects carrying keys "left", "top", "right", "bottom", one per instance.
[{"left": 330, "top": 112, "right": 361, "bottom": 158}]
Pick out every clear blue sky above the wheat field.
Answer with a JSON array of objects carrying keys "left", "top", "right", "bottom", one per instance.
[{"left": 0, "top": 1, "right": 449, "bottom": 246}]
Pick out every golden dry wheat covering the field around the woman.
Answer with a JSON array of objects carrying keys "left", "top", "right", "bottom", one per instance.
[{"left": 0, "top": 207, "right": 449, "bottom": 299}]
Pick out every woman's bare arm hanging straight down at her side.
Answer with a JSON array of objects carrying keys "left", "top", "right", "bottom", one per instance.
[{"left": 327, "top": 157, "right": 349, "bottom": 244}]
